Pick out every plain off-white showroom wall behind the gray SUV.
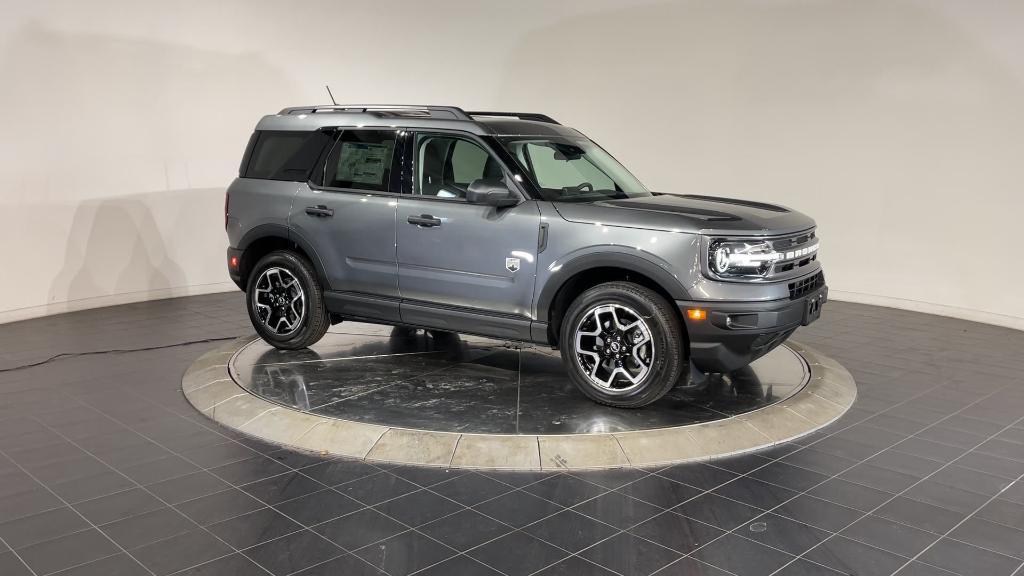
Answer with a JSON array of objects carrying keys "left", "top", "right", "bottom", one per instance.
[{"left": 0, "top": 0, "right": 1024, "bottom": 328}]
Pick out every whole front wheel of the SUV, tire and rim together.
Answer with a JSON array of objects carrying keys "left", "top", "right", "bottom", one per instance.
[{"left": 559, "top": 282, "right": 686, "bottom": 408}]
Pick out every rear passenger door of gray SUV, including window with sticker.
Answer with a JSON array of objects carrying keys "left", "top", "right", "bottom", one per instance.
[{"left": 290, "top": 129, "right": 401, "bottom": 322}]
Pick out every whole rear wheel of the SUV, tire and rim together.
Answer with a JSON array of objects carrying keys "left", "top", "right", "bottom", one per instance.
[{"left": 246, "top": 250, "right": 331, "bottom": 349}]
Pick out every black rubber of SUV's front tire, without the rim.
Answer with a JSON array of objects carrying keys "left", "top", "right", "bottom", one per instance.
[{"left": 560, "top": 283, "right": 684, "bottom": 408}]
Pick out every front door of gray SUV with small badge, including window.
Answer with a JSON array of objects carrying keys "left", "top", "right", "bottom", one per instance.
[{"left": 396, "top": 132, "right": 541, "bottom": 339}]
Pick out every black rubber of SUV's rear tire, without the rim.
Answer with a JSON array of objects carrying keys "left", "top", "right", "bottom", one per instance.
[{"left": 246, "top": 251, "right": 324, "bottom": 349}]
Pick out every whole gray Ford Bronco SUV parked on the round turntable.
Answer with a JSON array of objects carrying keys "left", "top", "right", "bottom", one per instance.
[{"left": 224, "top": 105, "right": 827, "bottom": 407}]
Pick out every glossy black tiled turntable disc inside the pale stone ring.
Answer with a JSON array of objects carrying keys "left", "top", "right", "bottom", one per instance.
[{"left": 230, "top": 323, "right": 810, "bottom": 435}]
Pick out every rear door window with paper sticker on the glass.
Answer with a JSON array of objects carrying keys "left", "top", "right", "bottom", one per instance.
[{"left": 324, "top": 130, "right": 398, "bottom": 192}]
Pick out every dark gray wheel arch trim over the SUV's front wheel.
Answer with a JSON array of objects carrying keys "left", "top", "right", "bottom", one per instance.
[{"left": 537, "top": 252, "right": 689, "bottom": 344}]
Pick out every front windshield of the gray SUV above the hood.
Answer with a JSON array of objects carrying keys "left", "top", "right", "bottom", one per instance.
[{"left": 498, "top": 136, "right": 650, "bottom": 202}]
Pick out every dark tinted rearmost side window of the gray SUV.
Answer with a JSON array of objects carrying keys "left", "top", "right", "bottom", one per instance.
[{"left": 243, "top": 130, "right": 331, "bottom": 181}]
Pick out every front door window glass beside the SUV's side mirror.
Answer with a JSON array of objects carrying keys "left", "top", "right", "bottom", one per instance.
[{"left": 414, "top": 134, "right": 503, "bottom": 199}]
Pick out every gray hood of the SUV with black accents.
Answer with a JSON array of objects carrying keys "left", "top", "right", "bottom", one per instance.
[{"left": 555, "top": 194, "right": 814, "bottom": 236}]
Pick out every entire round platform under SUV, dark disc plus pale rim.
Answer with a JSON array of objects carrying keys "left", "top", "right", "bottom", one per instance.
[{"left": 182, "top": 323, "right": 856, "bottom": 469}]
